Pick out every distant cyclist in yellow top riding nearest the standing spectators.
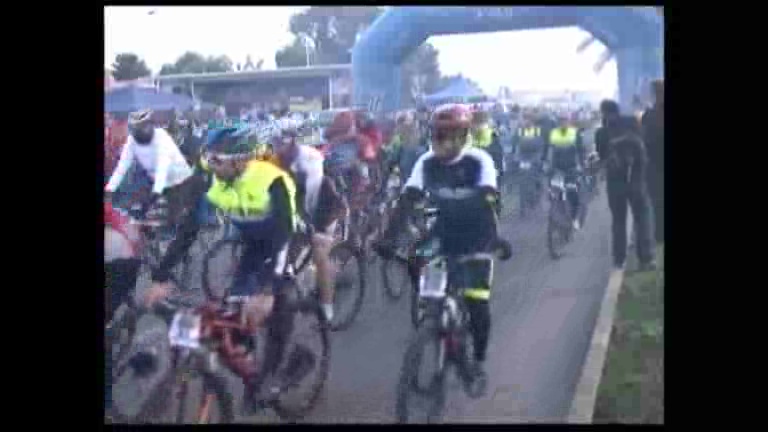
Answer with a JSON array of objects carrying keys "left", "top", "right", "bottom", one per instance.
[{"left": 545, "top": 116, "right": 585, "bottom": 230}]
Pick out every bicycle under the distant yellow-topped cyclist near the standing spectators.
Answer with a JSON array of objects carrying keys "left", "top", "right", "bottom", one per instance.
[{"left": 547, "top": 171, "right": 587, "bottom": 260}]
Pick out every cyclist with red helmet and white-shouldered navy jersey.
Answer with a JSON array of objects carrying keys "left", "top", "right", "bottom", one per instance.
[{"left": 374, "top": 105, "right": 506, "bottom": 388}]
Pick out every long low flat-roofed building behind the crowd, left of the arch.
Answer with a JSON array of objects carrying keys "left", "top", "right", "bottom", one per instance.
[{"left": 154, "top": 64, "right": 352, "bottom": 116}]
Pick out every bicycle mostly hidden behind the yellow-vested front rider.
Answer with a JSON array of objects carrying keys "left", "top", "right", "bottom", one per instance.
[{"left": 202, "top": 216, "right": 366, "bottom": 331}]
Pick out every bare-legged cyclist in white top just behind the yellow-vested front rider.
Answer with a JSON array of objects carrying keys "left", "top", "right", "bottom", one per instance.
[{"left": 271, "top": 120, "right": 344, "bottom": 321}]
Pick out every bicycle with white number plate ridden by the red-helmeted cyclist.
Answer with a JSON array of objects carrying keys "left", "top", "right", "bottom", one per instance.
[{"left": 396, "top": 242, "right": 511, "bottom": 423}]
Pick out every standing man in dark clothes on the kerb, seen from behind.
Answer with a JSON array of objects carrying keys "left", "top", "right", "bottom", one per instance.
[{"left": 595, "top": 101, "right": 656, "bottom": 271}]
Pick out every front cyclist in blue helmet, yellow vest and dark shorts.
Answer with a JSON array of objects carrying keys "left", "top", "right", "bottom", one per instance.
[{"left": 147, "top": 128, "right": 314, "bottom": 404}]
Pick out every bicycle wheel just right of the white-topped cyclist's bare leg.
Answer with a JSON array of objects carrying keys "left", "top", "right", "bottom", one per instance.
[{"left": 330, "top": 242, "right": 366, "bottom": 331}]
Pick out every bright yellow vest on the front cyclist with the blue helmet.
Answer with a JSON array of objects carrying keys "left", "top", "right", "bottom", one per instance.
[{"left": 207, "top": 160, "right": 296, "bottom": 224}]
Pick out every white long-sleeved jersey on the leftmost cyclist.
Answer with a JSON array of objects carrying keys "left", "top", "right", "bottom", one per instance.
[{"left": 106, "top": 128, "right": 192, "bottom": 193}]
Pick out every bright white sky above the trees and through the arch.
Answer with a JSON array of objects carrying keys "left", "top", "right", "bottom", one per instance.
[{"left": 104, "top": 6, "right": 618, "bottom": 96}]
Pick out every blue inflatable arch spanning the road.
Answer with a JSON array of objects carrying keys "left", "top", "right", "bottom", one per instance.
[{"left": 352, "top": 6, "right": 664, "bottom": 111}]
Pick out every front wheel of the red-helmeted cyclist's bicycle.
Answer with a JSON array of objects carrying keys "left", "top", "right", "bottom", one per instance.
[{"left": 395, "top": 326, "right": 447, "bottom": 423}]
